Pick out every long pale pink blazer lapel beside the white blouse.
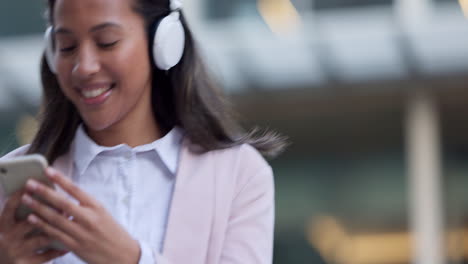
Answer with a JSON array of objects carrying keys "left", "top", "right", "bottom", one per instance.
[{"left": 162, "top": 139, "right": 216, "bottom": 263}]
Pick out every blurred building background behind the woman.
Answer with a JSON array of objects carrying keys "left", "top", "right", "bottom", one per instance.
[{"left": 0, "top": 0, "right": 468, "bottom": 264}]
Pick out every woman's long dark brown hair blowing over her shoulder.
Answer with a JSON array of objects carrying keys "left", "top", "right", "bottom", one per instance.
[{"left": 29, "top": 0, "right": 286, "bottom": 163}]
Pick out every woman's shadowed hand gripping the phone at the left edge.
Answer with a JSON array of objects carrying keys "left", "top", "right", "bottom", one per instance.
[{"left": 0, "top": 190, "right": 67, "bottom": 264}]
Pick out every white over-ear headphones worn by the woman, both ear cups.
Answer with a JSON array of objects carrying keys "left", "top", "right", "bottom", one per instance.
[{"left": 44, "top": 0, "right": 185, "bottom": 74}]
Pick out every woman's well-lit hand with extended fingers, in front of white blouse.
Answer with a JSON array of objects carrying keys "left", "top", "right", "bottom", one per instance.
[{"left": 22, "top": 168, "right": 140, "bottom": 264}]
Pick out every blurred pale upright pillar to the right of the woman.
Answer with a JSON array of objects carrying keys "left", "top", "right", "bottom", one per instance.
[{"left": 406, "top": 89, "right": 444, "bottom": 264}]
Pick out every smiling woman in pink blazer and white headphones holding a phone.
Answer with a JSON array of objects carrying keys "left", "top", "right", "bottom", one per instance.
[{"left": 0, "top": 0, "right": 285, "bottom": 264}]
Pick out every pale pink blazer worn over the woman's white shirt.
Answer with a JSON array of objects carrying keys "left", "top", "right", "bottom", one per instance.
[{"left": 0, "top": 139, "right": 274, "bottom": 264}]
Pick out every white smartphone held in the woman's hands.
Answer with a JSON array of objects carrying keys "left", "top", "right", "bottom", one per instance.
[{"left": 0, "top": 154, "right": 65, "bottom": 250}]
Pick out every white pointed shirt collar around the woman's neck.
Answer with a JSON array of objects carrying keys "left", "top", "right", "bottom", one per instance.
[{"left": 72, "top": 124, "right": 183, "bottom": 175}]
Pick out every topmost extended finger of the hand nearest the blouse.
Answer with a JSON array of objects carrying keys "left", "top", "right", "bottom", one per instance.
[{"left": 46, "top": 167, "right": 96, "bottom": 207}]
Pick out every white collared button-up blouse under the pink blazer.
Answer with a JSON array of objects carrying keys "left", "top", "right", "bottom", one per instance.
[{"left": 53, "top": 126, "right": 183, "bottom": 264}]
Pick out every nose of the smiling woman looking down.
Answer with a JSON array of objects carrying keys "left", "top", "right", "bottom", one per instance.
[{"left": 73, "top": 45, "right": 101, "bottom": 79}]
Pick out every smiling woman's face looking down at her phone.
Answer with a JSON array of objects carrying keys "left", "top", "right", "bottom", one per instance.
[{"left": 53, "top": 0, "right": 152, "bottom": 131}]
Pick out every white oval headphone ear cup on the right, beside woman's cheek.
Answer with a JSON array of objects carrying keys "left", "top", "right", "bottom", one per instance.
[{"left": 153, "top": 11, "right": 185, "bottom": 70}]
